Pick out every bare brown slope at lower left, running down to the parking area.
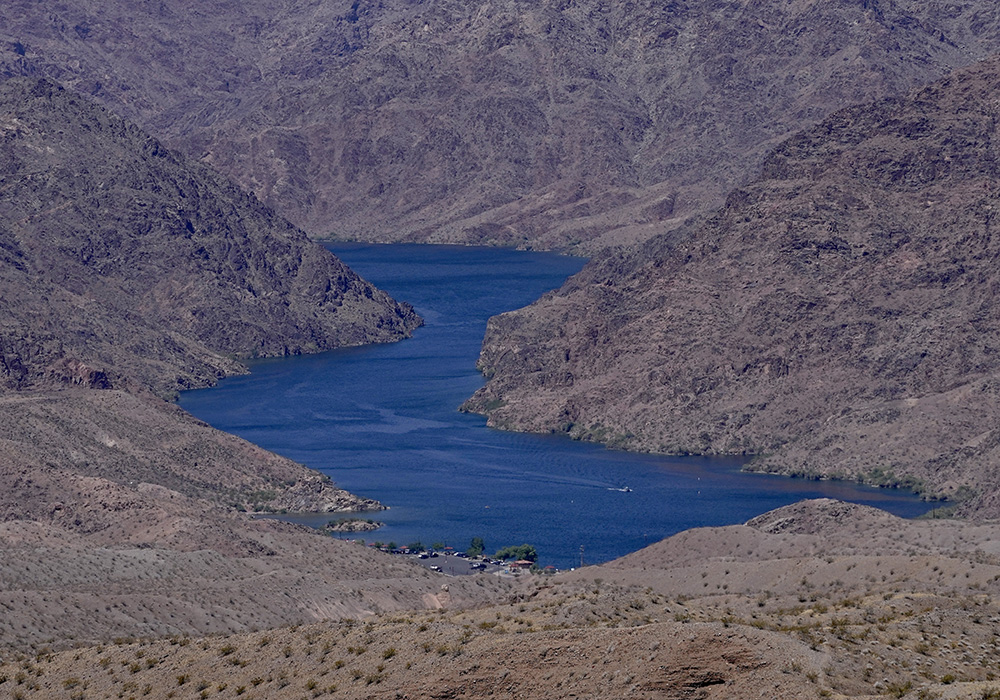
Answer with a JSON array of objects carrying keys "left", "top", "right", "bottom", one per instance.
[{"left": 0, "top": 498, "right": 506, "bottom": 652}]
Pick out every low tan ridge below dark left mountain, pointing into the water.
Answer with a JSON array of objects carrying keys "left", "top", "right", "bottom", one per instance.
[{"left": 0, "top": 388, "right": 384, "bottom": 548}]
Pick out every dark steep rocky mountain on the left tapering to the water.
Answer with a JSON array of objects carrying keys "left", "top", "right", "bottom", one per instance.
[{"left": 0, "top": 79, "right": 419, "bottom": 393}]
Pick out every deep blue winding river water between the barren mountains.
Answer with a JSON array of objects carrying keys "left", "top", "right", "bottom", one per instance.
[{"left": 180, "top": 244, "right": 930, "bottom": 568}]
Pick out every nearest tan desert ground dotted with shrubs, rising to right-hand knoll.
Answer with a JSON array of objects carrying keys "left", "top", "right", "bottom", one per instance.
[{"left": 0, "top": 501, "right": 1000, "bottom": 699}]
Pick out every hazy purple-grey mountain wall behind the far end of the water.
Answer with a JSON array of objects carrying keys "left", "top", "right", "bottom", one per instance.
[{"left": 0, "top": 0, "right": 1000, "bottom": 248}]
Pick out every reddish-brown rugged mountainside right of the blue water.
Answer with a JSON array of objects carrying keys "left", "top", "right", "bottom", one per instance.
[{"left": 467, "top": 59, "right": 1000, "bottom": 516}]
